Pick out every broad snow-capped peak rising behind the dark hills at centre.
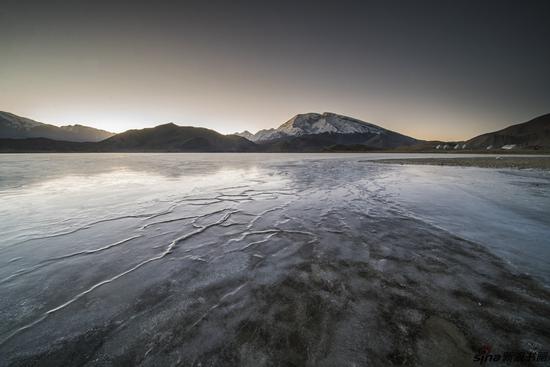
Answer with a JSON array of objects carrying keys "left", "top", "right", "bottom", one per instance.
[{"left": 237, "top": 112, "right": 388, "bottom": 142}]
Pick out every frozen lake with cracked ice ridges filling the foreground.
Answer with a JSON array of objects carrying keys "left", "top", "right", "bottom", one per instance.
[{"left": 0, "top": 154, "right": 550, "bottom": 366}]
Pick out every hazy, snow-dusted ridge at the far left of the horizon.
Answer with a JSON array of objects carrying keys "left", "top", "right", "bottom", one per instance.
[{"left": 0, "top": 111, "right": 114, "bottom": 142}]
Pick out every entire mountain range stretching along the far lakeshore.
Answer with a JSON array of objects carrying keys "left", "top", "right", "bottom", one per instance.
[{"left": 0, "top": 112, "right": 550, "bottom": 152}]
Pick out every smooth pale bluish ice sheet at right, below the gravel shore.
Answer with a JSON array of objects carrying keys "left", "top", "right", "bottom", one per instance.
[{"left": 380, "top": 166, "right": 550, "bottom": 284}]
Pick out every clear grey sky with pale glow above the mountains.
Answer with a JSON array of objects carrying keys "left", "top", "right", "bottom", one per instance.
[{"left": 0, "top": 0, "right": 550, "bottom": 140}]
